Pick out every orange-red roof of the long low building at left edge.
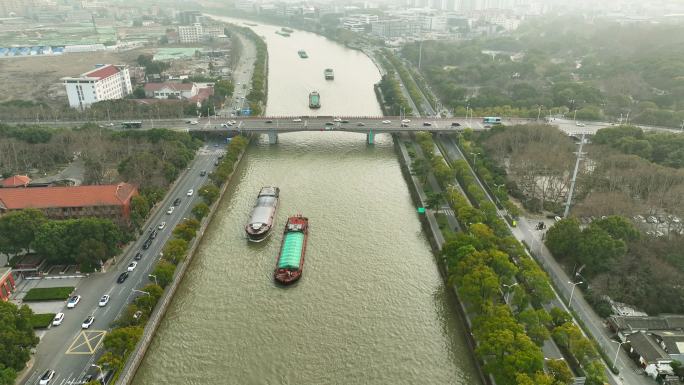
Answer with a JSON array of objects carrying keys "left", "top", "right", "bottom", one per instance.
[{"left": 0, "top": 183, "right": 136, "bottom": 210}]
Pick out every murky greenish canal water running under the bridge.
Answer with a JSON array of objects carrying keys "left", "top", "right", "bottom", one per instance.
[{"left": 134, "top": 16, "right": 479, "bottom": 385}]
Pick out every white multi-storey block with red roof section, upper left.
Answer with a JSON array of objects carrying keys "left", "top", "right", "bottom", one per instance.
[{"left": 62, "top": 64, "right": 133, "bottom": 109}]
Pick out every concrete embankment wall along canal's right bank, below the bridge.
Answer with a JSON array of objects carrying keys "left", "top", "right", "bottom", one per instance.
[{"left": 394, "top": 135, "right": 493, "bottom": 384}]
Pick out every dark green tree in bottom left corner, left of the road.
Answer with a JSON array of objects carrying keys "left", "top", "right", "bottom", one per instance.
[{"left": 0, "top": 301, "right": 38, "bottom": 377}]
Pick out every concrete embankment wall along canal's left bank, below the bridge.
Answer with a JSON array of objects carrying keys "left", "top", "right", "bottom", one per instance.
[{"left": 116, "top": 142, "right": 247, "bottom": 385}]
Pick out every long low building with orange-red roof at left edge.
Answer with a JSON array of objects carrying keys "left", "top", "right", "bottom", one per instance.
[{"left": 0, "top": 183, "right": 138, "bottom": 223}]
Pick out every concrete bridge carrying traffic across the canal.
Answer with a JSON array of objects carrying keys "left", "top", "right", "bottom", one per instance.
[{"left": 190, "top": 116, "right": 484, "bottom": 144}]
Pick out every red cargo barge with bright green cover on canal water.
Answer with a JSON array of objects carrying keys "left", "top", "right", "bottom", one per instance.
[{"left": 273, "top": 214, "right": 309, "bottom": 285}]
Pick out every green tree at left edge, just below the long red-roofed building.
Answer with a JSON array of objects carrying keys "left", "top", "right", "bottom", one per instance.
[{"left": 0, "top": 209, "right": 46, "bottom": 255}]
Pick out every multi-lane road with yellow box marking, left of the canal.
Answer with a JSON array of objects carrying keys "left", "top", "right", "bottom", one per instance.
[{"left": 22, "top": 144, "right": 224, "bottom": 385}]
